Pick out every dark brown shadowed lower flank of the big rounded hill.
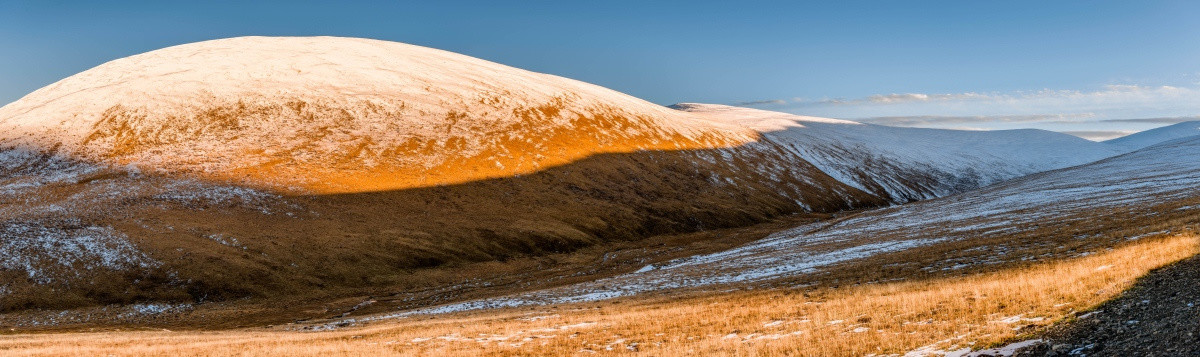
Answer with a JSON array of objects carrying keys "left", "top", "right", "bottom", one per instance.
[{"left": 2, "top": 144, "right": 887, "bottom": 321}]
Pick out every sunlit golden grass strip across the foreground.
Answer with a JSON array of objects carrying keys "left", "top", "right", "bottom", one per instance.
[{"left": 0, "top": 236, "right": 1200, "bottom": 356}]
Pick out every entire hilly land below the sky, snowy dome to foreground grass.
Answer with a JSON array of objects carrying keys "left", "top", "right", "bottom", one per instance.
[{"left": 0, "top": 37, "right": 1200, "bottom": 356}]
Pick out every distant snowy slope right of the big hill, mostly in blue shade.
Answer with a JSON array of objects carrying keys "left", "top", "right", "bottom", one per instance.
[{"left": 673, "top": 103, "right": 1123, "bottom": 202}]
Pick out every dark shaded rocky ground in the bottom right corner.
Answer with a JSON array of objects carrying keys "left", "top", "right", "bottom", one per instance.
[{"left": 1016, "top": 256, "right": 1200, "bottom": 356}]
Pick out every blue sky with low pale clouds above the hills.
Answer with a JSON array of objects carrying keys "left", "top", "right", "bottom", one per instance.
[{"left": 0, "top": 0, "right": 1200, "bottom": 138}]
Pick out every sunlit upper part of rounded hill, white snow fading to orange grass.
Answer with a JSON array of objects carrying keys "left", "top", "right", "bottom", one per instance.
[{"left": 0, "top": 37, "right": 755, "bottom": 192}]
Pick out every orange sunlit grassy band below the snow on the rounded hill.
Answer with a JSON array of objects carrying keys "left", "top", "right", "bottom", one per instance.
[{"left": 91, "top": 95, "right": 758, "bottom": 194}]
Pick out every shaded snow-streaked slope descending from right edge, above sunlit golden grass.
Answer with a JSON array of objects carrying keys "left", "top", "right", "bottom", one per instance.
[{"left": 392, "top": 137, "right": 1200, "bottom": 316}]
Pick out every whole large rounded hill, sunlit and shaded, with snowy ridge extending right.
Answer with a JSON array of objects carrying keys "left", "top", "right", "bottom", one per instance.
[{"left": 0, "top": 37, "right": 1132, "bottom": 319}]
